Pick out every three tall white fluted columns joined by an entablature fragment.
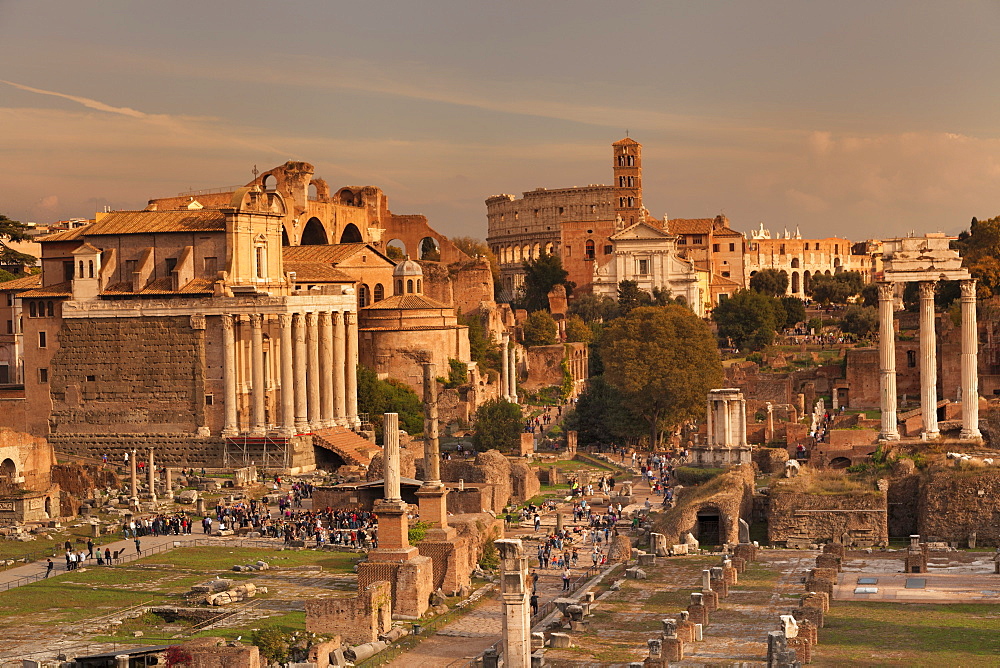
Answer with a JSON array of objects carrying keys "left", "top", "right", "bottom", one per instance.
[{"left": 877, "top": 234, "right": 982, "bottom": 441}]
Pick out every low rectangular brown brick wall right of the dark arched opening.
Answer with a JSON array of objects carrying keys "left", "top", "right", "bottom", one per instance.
[{"left": 767, "top": 485, "right": 889, "bottom": 547}]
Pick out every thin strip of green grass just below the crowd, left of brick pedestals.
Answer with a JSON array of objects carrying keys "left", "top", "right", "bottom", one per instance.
[{"left": 140, "top": 547, "right": 359, "bottom": 573}]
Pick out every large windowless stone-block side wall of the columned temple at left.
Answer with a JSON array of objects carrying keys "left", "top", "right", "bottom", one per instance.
[{"left": 49, "top": 317, "right": 205, "bottom": 434}]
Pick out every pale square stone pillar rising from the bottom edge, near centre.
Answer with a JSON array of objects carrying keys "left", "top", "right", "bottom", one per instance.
[{"left": 495, "top": 538, "right": 531, "bottom": 668}]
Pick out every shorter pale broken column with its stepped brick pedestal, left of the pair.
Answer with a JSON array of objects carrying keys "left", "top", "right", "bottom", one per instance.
[{"left": 358, "top": 413, "right": 434, "bottom": 619}]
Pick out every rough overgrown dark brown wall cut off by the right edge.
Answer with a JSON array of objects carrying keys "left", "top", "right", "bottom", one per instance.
[{"left": 918, "top": 469, "right": 1000, "bottom": 547}]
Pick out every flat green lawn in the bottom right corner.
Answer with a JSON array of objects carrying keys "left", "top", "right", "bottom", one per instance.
[{"left": 813, "top": 601, "right": 1000, "bottom": 666}]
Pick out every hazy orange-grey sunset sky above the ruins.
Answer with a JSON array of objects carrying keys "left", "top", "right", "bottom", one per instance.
[{"left": 0, "top": 0, "right": 1000, "bottom": 240}]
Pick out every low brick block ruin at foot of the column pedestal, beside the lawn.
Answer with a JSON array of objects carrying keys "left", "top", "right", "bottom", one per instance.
[{"left": 305, "top": 572, "right": 392, "bottom": 645}]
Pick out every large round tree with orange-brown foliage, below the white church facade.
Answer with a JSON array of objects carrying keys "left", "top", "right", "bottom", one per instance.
[{"left": 600, "top": 305, "right": 722, "bottom": 447}]
